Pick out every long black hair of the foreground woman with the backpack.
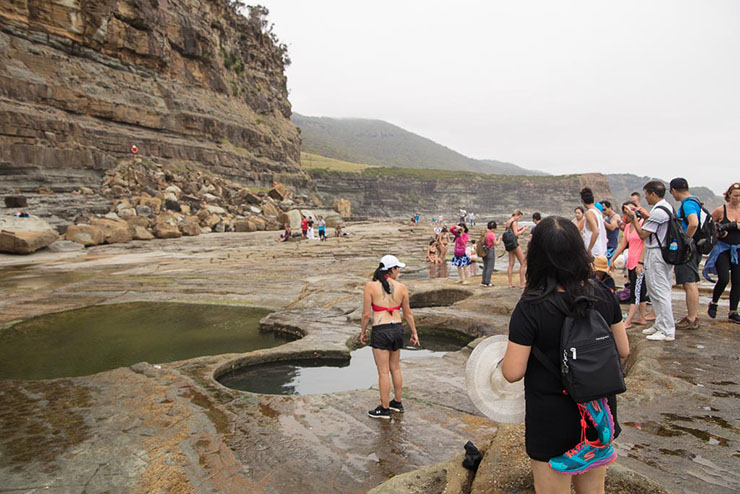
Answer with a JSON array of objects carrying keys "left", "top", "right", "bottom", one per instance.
[{"left": 523, "top": 216, "right": 593, "bottom": 316}]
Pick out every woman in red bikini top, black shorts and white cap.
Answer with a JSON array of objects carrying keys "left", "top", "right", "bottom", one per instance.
[{"left": 360, "top": 255, "right": 419, "bottom": 419}]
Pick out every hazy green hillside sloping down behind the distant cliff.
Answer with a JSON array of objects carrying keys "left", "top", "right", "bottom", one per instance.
[{"left": 291, "top": 113, "right": 546, "bottom": 175}]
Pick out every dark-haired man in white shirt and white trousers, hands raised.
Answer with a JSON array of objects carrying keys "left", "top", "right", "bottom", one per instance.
[{"left": 625, "top": 180, "right": 680, "bottom": 341}]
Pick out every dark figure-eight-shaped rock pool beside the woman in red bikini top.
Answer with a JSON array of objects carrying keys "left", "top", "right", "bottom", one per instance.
[{"left": 217, "top": 329, "right": 473, "bottom": 395}]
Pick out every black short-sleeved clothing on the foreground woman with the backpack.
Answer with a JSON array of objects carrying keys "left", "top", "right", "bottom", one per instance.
[{"left": 509, "top": 283, "right": 622, "bottom": 461}]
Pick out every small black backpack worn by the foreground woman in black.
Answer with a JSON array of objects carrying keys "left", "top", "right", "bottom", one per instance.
[{"left": 532, "top": 296, "right": 627, "bottom": 403}]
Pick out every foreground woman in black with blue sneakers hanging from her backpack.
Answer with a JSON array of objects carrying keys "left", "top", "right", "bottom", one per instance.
[{"left": 501, "top": 216, "right": 629, "bottom": 493}]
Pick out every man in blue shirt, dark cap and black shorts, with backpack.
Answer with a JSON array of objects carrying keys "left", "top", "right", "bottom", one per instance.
[{"left": 669, "top": 177, "right": 716, "bottom": 329}]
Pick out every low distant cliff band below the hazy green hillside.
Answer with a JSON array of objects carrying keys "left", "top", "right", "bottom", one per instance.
[{"left": 311, "top": 169, "right": 614, "bottom": 217}]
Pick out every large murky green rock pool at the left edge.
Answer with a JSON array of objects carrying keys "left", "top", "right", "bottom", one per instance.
[{"left": 0, "top": 302, "right": 293, "bottom": 379}]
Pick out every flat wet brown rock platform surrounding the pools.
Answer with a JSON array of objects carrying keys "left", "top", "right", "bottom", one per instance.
[{"left": 0, "top": 222, "right": 740, "bottom": 493}]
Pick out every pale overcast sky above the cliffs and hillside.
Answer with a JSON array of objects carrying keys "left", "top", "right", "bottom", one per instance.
[{"left": 263, "top": 0, "right": 740, "bottom": 192}]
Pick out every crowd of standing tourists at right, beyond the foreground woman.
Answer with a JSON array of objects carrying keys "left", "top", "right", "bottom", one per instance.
[{"left": 573, "top": 177, "right": 740, "bottom": 341}]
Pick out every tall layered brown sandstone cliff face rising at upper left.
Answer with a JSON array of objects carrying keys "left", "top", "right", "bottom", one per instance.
[{"left": 0, "top": 0, "right": 309, "bottom": 192}]
